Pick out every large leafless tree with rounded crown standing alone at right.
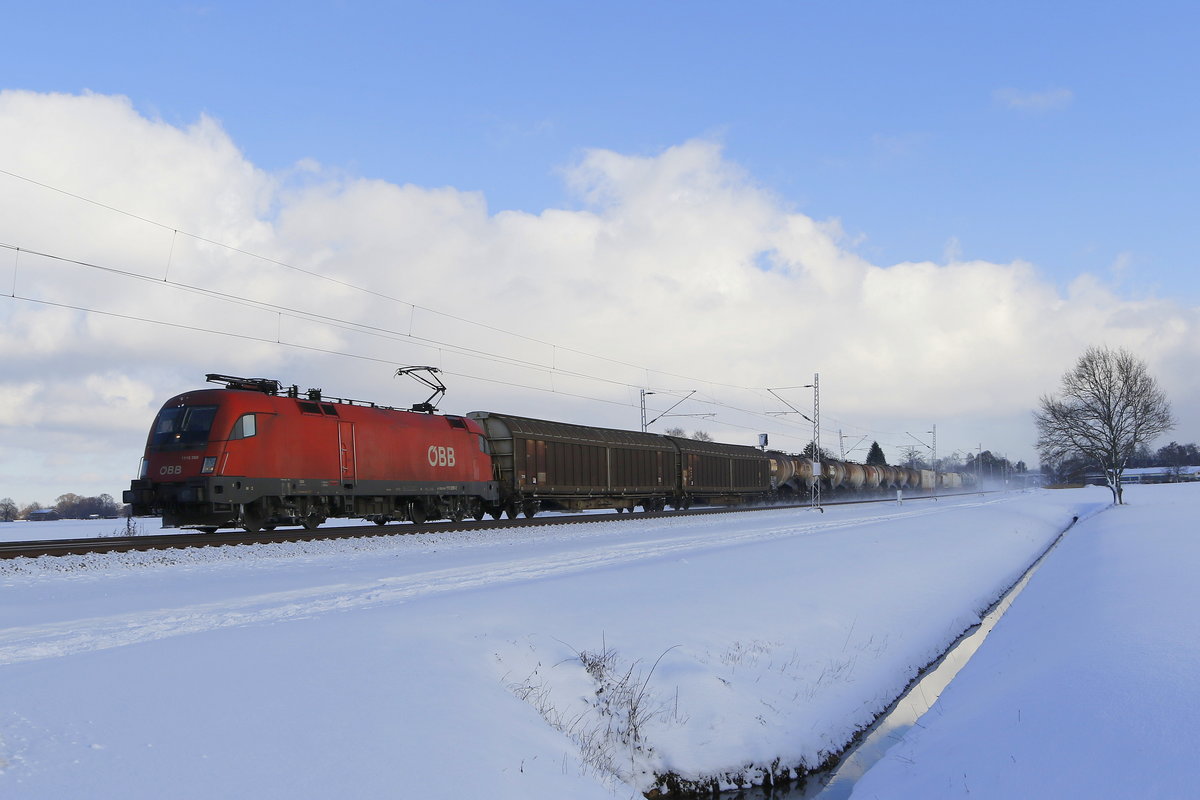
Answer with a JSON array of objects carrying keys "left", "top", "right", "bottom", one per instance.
[{"left": 1033, "top": 347, "right": 1175, "bottom": 504}]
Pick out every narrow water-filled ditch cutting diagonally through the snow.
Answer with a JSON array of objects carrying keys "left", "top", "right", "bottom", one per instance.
[{"left": 716, "top": 517, "right": 1079, "bottom": 800}]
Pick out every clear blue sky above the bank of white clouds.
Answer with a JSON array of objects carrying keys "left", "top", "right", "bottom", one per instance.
[{"left": 0, "top": 1, "right": 1200, "bottom": 298}]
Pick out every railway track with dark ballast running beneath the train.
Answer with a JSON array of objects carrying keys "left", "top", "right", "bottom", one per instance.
[{"left": 0, "top": 492, "right": 988, "bottom": 559}]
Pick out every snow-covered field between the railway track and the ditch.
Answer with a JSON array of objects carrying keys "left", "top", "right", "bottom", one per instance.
[{"left": 0, "top": 489, "right": 1108, "bottom": 799}]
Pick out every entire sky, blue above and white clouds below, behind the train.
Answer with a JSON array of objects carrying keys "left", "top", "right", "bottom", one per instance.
[{"left": 0, "top": 1, "right": 1200, "bottom": 500}]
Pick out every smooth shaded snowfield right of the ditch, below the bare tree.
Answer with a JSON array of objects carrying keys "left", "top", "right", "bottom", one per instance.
[{"left": 853, "top": 485, "right": 1200, "bottom": 800}]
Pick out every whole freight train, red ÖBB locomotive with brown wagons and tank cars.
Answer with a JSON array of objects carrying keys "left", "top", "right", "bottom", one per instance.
[{"left": 124, "top": 374, "right": 964, "bottom": 533}]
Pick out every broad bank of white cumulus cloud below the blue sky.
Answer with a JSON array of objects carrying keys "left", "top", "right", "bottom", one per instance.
[{"left": 0, "top": 92, "right": 1200, "bottom": 503}]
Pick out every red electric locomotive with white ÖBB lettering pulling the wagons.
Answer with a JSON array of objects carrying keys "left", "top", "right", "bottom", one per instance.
[{"left": 124, "top": 375, "right": 499, "bottom": 531}]
